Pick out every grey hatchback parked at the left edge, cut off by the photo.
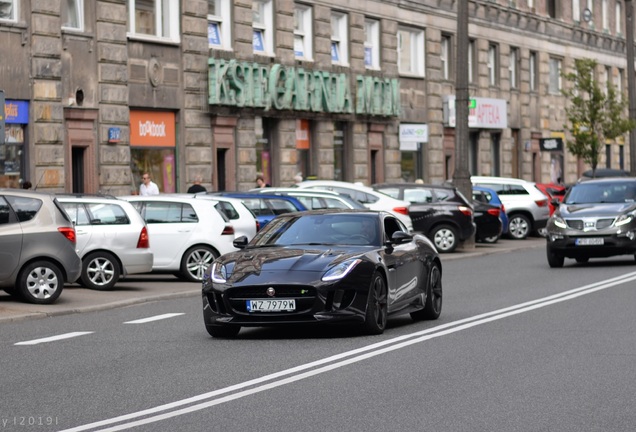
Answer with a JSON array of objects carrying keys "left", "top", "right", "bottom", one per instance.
[{"left": 0, "top": 189, "right": 82, "bottom": 304}]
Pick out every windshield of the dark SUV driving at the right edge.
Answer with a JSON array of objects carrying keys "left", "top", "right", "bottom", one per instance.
[{"left": 564, "top": 182, "right": 636, "bottom": 204}]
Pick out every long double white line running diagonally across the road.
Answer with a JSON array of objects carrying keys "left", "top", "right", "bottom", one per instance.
[{"left": 60, "top": 272, "right": 636, "bottom": 432}]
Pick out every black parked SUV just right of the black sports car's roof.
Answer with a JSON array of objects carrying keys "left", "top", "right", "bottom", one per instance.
[{"left": 372, "top": 183, "right": 475, "bottom": 253}]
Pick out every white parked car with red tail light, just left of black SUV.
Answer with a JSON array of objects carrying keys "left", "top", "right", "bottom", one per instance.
[{"left": 296, "top": 180, "right": 413, "bottom": 232}]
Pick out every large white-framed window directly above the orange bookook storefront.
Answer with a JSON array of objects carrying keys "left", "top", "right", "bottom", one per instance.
[{"left": 128, "top": 0, "right": 181, "bottom": 42}]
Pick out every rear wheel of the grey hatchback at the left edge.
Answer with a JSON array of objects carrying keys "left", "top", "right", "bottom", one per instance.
[{"left": 16, "top": 261, "right": 64, "bottom": 304}]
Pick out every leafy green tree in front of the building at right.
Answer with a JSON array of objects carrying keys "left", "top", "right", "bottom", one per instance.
[{"left": 561, "top": 59, "right": 636, "bottom": 175}]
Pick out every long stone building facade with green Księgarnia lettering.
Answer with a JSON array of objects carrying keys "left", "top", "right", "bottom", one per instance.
[{"left": 0, "top": 0, "right": 630, "bottom": 195}]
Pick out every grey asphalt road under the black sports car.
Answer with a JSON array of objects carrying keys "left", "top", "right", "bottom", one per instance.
[{"left": 0, "top": 238, "right": 636, "bottom": 432}]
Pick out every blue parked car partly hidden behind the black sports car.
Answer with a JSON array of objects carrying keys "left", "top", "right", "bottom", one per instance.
[{"left": 210, "top": 192, "right": 307, "bottom": 229}]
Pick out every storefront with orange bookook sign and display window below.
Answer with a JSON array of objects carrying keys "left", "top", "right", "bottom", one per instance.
[{"left": 130, "top": 110, "right": 177, "bottom": 193}]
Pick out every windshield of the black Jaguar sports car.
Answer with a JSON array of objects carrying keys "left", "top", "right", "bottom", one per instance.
[{"left": 250, "top": 214, "right": 382, "bottom": 247}]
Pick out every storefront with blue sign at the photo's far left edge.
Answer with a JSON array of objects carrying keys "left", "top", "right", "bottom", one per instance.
[{"left": 0, "top": 99, "right": 28, "bottom": 188}]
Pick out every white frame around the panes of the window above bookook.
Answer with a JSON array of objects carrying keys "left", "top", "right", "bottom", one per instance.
[{"left": 126, "top": 0, "right": 181, "bottom": 43}]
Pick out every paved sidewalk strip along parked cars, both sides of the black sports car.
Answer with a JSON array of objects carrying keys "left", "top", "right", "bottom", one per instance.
[{"left": 0, "top": 237, "right": 545, "bottom": 323}]
